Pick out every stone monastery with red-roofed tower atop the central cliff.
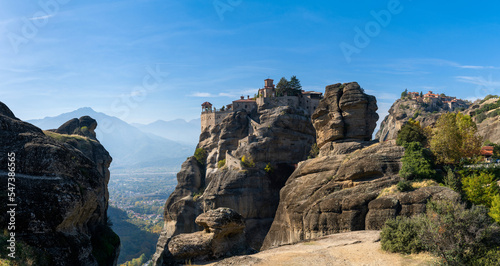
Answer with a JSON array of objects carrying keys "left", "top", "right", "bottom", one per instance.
[{"left": 201, "top": 79, "right": 323, "bottom": 131}]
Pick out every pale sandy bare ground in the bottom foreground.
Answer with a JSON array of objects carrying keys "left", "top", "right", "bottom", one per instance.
[{"left": 207, "top": 231, "right": 435, "bottom": 266}]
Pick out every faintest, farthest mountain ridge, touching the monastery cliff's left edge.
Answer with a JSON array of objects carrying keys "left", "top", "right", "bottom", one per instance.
[{"left": 132, "top": 118, "right": 201, "bottom": 145}]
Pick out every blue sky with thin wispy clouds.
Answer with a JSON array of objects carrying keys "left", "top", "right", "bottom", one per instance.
[{"left": 0, "top": 0, "right": 500, "bottom": 123}]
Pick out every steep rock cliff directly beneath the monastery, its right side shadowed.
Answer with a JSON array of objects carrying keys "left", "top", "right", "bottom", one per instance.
[{"left": 153, "top": 104, "right": 315, "bottom": 265}]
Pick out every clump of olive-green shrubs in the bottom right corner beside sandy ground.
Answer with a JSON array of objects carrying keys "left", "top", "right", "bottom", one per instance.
[{"left": 381, "top": 201, "right": 500, "bottom": 265}]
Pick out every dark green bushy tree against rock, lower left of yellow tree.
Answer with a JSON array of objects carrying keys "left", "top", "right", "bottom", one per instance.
[{"left": 399, "top": 142, "right": 436, "bottom": 180}]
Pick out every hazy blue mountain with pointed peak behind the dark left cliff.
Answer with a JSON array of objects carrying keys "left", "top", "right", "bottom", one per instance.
[{"left": 28, "top": 107, "right": 195, "bottom": 170}]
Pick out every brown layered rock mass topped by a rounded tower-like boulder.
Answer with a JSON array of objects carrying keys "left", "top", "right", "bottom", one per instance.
[{"left": 262, "top": 83, "right": 458, "bottom": 249}]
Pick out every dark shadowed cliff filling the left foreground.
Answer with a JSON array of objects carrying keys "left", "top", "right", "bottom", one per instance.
[{"left": 0, "top": 102, "right": 120, "bottom": 265}]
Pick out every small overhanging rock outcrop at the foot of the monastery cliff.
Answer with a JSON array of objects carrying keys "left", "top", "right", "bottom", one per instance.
[{"left": 168, "top": 208, "right": 251, "bottom": 263}]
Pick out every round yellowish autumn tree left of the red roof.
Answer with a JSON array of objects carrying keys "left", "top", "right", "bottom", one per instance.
[{"left": 430, "top": 113, "right": 481, "bottom": 163}]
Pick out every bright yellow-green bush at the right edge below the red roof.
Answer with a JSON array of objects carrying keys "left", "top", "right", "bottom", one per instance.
[{"left": 462, "top": 173, "right": 500, "bottom": 207}]
